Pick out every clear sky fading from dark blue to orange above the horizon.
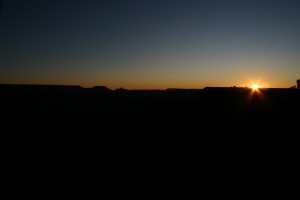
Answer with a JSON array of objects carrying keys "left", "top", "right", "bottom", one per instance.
[{"left": 0, "top": 0, "right": 300, "bottom": 89}]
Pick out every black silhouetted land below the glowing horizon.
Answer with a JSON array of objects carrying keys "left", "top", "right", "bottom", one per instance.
[{"left": 0, "top": 85, "right": 300, "bottom": 199}]
